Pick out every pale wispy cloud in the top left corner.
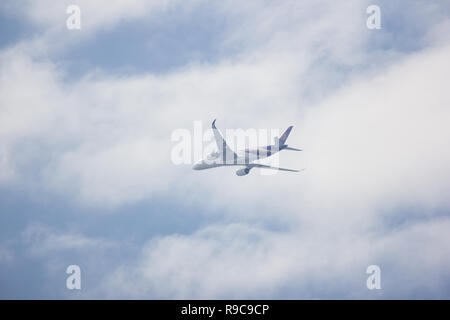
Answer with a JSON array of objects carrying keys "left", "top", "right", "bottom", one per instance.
[{"left": 0, "top": 0, "right": 202, "bottom": 59}]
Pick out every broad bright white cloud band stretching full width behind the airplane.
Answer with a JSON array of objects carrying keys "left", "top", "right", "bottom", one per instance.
[{"left": 0, "top": 3, "right": 449, "bottom": 215}]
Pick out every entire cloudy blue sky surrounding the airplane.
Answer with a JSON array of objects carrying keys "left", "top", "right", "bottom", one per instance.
[{"left": 0, "top": 0, "right": 450, "bottom": 299}]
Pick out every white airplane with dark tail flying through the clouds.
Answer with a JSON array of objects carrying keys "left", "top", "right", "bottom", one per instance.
[{"left": 192, "top": 120, "right": 302, "bottom": 176}]
